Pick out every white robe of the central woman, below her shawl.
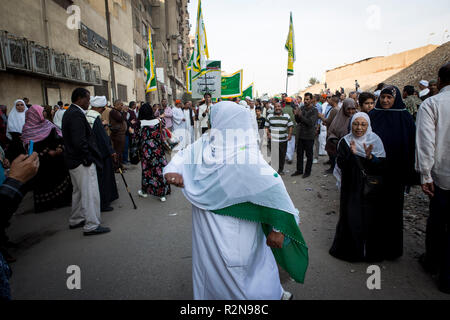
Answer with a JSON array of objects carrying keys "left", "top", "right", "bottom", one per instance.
[{"left": 192, "top": 206, "right": 283, "bottom": 300}]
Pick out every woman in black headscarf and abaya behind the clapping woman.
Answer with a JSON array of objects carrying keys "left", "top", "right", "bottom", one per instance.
[{"left": 369, "top": 86, "right": 418, "bottom": 260}]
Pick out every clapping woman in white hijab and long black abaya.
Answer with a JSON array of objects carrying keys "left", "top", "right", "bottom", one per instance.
[{"left": 330, "top": 112, "right": 386, "bottom": 262}]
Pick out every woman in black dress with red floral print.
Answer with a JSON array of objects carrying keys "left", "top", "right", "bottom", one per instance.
[{"left": 138, "top": 103, "right": 170, "bottom": 202}]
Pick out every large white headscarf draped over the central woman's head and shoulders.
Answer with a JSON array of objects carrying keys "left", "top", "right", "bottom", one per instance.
[{"left": 164, "top": 101, "right": 298, "bottom": 220}]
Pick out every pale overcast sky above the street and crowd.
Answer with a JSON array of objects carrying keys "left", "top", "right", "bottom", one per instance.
[{"left": 188, "top": 0, "right": 450, "bottom": 96}]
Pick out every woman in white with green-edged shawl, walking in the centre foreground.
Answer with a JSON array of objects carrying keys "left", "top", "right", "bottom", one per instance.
[{"left": 164, "top": 101, "right": 308, "bottom": 300}]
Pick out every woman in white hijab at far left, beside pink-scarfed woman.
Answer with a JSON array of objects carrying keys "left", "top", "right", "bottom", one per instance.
[{"left": 6, "top": 100, "right": 28, "bottom": 162}]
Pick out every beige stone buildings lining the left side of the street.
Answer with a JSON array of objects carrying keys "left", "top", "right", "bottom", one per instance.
[{"left": 0, "top": 0, "right": 190, "bottom": 109}]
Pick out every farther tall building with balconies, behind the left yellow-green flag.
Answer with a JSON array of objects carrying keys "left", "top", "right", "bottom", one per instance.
[{"left": 132, "top": 0, "right": 191, "bottom": 102}]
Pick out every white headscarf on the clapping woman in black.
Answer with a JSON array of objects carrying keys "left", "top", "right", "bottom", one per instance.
[{"left": 343, "top": 112, "right": 386, "bottom": 158}]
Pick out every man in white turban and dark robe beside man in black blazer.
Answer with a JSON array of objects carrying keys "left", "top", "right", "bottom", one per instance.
[{"left": 86, "top": 96, "right": 119, "bottom": 212}]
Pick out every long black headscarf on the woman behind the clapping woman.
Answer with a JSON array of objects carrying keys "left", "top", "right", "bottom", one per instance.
[{"left": 369, "top": 86, "right": 417, "bottom": 184}]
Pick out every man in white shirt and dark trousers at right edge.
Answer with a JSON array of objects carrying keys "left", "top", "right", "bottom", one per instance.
[{"left": 416, "top": 62, "right": 450, "bottom": 294}]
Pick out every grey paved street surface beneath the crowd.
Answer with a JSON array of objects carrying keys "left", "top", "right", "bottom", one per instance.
[{"left": 9, "top": 158, "right": 450, "bottom": 300}]
